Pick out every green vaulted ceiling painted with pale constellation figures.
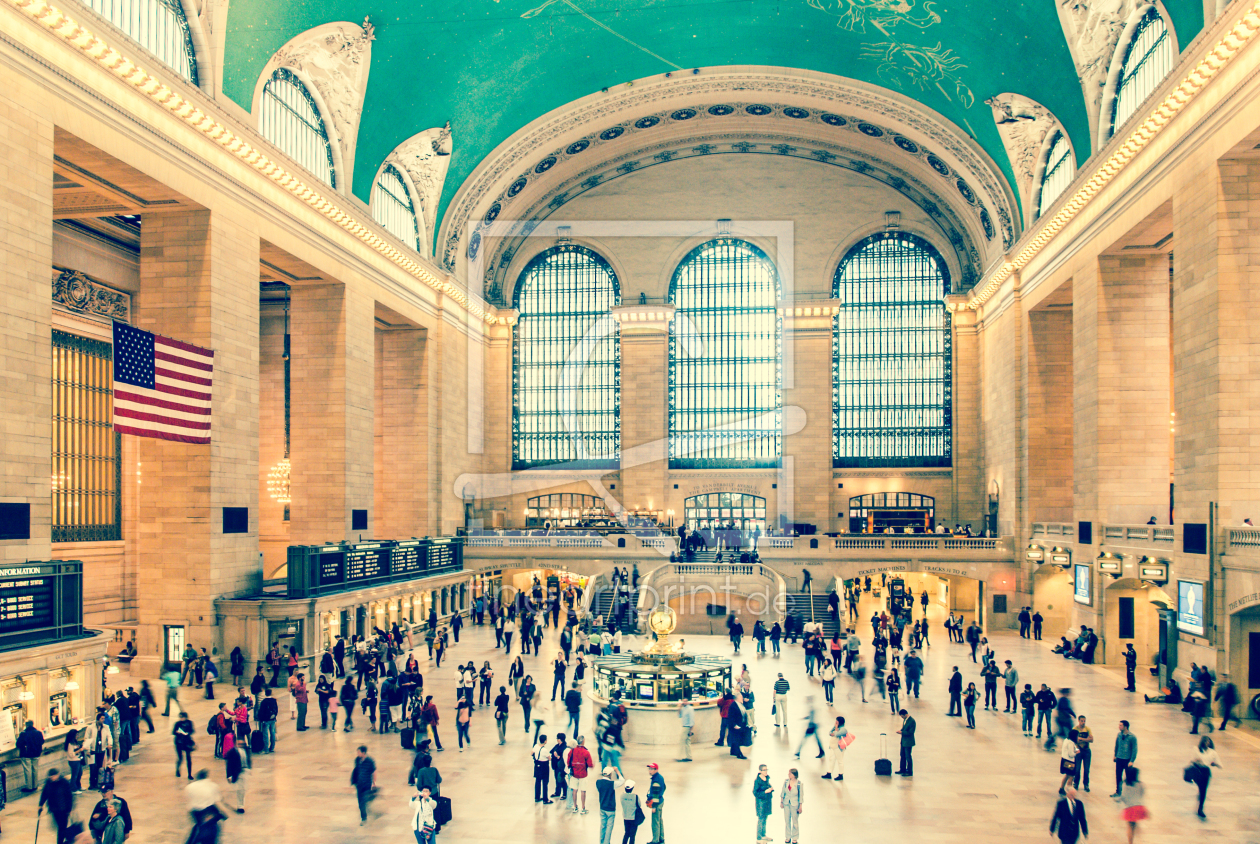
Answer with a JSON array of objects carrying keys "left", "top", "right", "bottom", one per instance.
[{"left": 223, "top": 0, "right": 1203, "bottom": 231}]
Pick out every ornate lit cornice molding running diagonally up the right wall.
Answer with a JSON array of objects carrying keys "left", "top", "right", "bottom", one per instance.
[{"left": 966, "top": 0, "right": 1260, "bottom": 310}]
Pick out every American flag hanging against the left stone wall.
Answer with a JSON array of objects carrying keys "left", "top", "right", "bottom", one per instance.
[{"left": 113, "top": 322, "right": 214, "bottom": 443}]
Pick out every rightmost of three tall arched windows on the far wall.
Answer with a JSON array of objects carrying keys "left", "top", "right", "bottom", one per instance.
[{"left": 832, "top": 233, "right": 951, "bottom": 467}]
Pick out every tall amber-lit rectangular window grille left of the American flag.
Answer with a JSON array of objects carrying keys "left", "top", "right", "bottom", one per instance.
[{"left": 52, "top": 331, "right": 122, "bottom": 542}]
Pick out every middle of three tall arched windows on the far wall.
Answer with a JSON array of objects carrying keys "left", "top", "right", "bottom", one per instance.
[{"left": 669, "top": 238, "right": 782, "bottom": 469}]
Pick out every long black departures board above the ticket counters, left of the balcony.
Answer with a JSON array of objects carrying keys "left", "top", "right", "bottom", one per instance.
[{"left": 286, "top": 538, "right": 464, "bottom": 598}]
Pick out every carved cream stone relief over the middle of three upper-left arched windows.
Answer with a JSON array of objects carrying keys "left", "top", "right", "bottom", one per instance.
[{"left": 263, "top": 19, "right": 377, "bottom": 189}]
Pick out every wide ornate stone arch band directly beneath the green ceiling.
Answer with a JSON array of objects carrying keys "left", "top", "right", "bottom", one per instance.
[{"left": 438, "top": 68, "right": 1016, "bottom": 270}]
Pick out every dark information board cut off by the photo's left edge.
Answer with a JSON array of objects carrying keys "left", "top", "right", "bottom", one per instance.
[{"left": 0, "top": 561, "right": 83, "bottom": 649}]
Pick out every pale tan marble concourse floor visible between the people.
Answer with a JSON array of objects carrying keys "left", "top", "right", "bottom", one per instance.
[{"left": 3, "top": 592, "right": 1260, "bottom": 844}]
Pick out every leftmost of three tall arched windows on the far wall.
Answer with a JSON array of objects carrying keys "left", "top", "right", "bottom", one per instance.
[{"left": 512, "top": 246, "right": 621, "bottom": 469}]
